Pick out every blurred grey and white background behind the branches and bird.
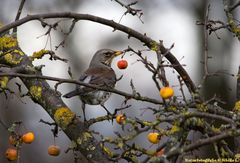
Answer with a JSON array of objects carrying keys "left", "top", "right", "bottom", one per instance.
[{"left": 0, "top": 0, "right": 240, "bottom": 163}]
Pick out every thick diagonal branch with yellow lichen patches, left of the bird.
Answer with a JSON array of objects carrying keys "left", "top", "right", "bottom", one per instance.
[{"left": 0, "top": 38, "right": 109, "bottom": 163}]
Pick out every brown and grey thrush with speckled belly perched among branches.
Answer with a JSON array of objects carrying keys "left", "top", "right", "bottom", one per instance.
[{"left": 63, "top": 49, "right": 123, "bottom": 121}]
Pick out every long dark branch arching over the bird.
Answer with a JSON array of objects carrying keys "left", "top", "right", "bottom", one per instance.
[{"left": 0, "top": 12, "right": 196, "bottom": 93}]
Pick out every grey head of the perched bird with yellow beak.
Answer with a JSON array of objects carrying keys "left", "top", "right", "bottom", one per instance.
[{"left": 90, "top": 49, "right": 123, "bottom": 66}]
